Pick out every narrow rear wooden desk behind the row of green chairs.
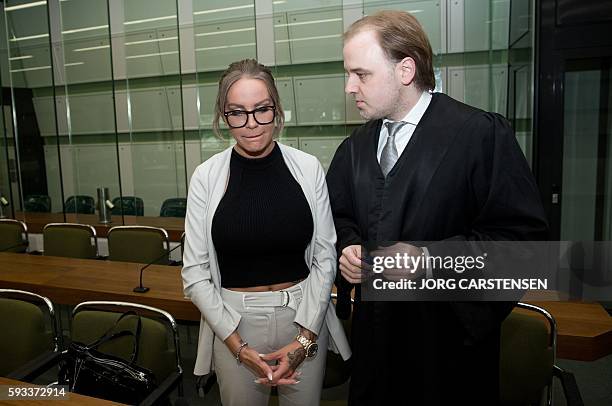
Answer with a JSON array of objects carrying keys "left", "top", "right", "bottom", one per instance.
[{"left": 15, "top": 212, "right": 185, "bottom": 241}]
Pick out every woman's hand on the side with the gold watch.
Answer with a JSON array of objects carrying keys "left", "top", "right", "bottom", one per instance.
[{"left": 256, "top": 340, "right": 306, "bottom": 386}]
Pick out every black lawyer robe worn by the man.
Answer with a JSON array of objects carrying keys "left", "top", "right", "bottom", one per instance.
[{"left": 327, "top": 93, "right": 547, "bottom": 405}]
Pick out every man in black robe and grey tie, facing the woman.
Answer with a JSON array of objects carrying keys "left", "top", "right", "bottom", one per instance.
[{"left": 327, "top": 12, "right": 547, "bottom": 406}]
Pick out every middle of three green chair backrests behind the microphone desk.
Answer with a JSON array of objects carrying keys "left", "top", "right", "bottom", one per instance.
[{"left": 43, "top": 223, "right": 98, "bottom": 259}]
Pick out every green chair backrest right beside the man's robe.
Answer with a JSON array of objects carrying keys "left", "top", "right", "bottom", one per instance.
[{"left": 500, "top": 303, "right": 557, "bottom": 406}]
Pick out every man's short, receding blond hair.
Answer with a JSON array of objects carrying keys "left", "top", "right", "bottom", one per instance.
[{"left": 344, "top": 11, "right": 436, "bottom": 90}]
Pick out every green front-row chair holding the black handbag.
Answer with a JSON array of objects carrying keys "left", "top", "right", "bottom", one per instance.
[{"left": 70, "top": 301, "right": 183, "bottom": 404}]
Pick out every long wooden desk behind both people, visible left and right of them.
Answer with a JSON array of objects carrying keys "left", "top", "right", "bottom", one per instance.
[{"left": 0, "top": 253, "right": 612, "bottom": 361}]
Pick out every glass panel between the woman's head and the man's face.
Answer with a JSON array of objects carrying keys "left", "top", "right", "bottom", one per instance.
[{"left": 273, "top": 0, "right": 350, "bottom": 170}]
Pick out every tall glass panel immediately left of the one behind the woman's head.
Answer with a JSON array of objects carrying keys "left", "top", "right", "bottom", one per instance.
[{"left": 117, "top": 0, "right": 187, "bottom": 222}]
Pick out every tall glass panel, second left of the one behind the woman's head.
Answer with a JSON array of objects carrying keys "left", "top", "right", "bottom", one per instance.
[{"left": 56, "top": 0, "right": 121, "bottom": 224}]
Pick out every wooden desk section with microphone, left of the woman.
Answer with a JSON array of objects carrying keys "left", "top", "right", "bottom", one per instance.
[{"left": 0, "top": 253, "right": 200, "bottom": 320}]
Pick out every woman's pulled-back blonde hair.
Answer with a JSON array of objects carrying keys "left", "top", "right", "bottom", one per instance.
[{"left": 213, "top": 59, "right": 285, "bottom": 137}]
